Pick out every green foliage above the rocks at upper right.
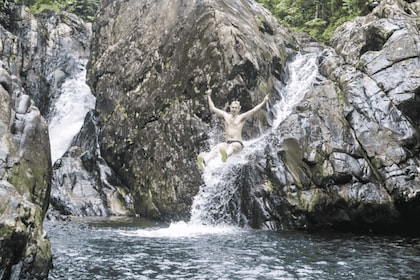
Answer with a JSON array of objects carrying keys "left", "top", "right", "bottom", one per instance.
[{"left": 257, "top": 0, "right": 369, "bottom": 42}]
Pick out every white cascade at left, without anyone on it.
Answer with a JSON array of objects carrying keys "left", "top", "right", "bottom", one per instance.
[{"left": 48, "top": 62, "right": 96, "bottom": 163}]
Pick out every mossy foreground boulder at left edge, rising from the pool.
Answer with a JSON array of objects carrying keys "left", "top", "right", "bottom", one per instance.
[{"left": 0, "top": 64, "right": 52, "bottom": 279}]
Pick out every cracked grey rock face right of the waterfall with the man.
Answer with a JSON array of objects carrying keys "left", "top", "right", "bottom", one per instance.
[{"left": 248, "top": 1, "right": 420, "bottom": 231}]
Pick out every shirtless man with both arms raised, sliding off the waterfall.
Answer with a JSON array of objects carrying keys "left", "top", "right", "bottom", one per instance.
[{"left": 197, "top": 89, "right": 268, "bottom": 169}]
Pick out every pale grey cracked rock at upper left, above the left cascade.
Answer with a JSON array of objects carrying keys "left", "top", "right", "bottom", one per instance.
[{"left": 0, "top": 1, "right": 91, "bottom": 117}]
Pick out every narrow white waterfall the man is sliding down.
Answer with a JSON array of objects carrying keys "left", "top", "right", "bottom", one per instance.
[{"left": 190, "top": 53, "right": 322, "bottom": 228}]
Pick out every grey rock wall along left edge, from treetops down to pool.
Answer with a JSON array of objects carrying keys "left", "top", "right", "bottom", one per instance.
[{"left": 0, "top": 0, "right": 90, "bottom": 279}]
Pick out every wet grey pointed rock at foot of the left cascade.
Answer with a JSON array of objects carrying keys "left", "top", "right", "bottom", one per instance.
[{"left": 51, "top": 112, "right": 135, "bottom": 216}]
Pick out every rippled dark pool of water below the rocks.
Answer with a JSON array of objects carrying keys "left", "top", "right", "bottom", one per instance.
[{"left": 45, "top": 219, "right": 420, "bottom": 279}]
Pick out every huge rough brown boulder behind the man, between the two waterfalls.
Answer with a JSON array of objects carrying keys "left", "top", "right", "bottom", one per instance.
[{"left": 88, "top": 0, "right": 296, "bottom": 219}]
